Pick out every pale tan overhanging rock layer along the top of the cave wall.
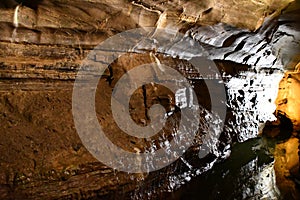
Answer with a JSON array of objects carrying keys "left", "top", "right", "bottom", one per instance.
[{"left": 0, "top": 0, "right": 292, "bottom": 45}]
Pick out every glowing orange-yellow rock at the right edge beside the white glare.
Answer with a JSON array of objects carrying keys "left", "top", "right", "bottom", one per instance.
[{"left": 273, "top": 67, "right": 300, "bottom": 199}]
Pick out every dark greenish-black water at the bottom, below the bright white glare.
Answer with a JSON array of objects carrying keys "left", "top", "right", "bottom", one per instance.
[{"left": 169, "top": 138, "right": 280, "bottom": 199}]
